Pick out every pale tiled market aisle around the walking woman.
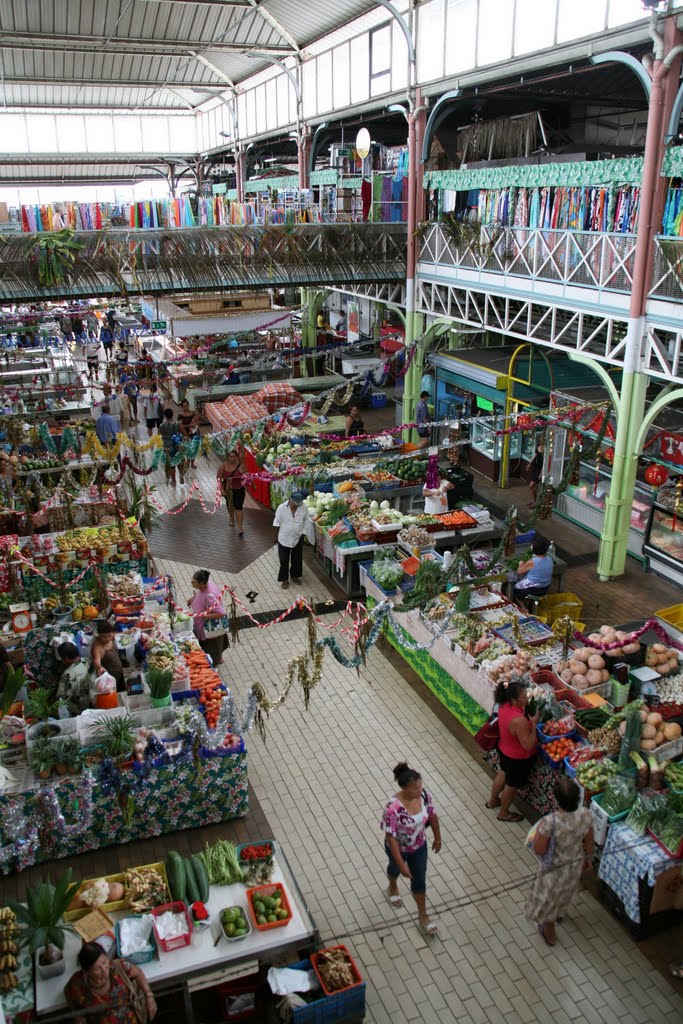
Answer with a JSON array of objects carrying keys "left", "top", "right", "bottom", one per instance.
[{"left": 163, "top": 553, "right": 683, "bottom": 1024}]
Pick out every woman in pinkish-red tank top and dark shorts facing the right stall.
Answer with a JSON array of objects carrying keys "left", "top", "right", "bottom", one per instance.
[{"left": 486, "top": 682, "right": 539, "bottom": 821}]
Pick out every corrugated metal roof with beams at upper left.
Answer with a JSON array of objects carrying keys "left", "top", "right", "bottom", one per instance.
[{"left": 0, "top": 0, "right": 376, "bottom": 109}]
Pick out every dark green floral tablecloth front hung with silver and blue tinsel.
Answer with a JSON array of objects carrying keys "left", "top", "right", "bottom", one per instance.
[{"left": 0, "top": 752, "right": 249, "bottom": 871}]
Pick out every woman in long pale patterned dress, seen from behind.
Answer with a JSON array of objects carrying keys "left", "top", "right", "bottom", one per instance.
[{"left": 526, "top": 775, "right": 593, "bottom": 946}]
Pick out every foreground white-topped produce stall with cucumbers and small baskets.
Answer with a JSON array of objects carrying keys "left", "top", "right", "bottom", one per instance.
[{"left": 22, "top": 840, "right": 325, "bottom": 1021}]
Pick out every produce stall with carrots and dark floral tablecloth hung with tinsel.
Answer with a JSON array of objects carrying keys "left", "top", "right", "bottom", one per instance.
[{"left": 0, "top": 570, "right": 248, "bottom": 873}]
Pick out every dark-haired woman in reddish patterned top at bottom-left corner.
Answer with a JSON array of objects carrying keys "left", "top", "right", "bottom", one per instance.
[{"left": 65, "top": 942, "right": 157, "bottom": 1024}]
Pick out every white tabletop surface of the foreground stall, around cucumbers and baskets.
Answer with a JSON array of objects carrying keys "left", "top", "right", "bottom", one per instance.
[{"left": 36, "top": 840, "right": 317, "bottom": 1019}]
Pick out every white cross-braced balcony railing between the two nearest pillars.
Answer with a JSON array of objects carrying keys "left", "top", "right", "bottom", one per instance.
[{"left": 420, "top": 224, "right": 643, "bottom": 298}]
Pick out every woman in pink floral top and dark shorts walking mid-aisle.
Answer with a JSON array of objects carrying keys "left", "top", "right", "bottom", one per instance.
[{"left": 381, "top": 761, "right": 441, "bottom": 935}]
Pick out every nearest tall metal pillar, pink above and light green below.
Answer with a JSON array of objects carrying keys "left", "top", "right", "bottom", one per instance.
[{"left": 598, "top": 18, "right": 680, "bottom": 581}]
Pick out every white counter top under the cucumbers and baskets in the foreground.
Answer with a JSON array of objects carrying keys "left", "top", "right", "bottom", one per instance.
[{"left": 36, "top": 843, "right": 317, "bottom": 1019}]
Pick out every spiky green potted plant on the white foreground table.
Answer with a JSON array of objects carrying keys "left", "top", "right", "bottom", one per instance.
[{"left": 9, "top": 867, "right": 79, "bottom": 978}]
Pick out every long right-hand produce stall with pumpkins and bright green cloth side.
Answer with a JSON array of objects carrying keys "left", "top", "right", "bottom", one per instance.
[{"left": 360, "top": 569, "right": 683, "bottom": 937}]
